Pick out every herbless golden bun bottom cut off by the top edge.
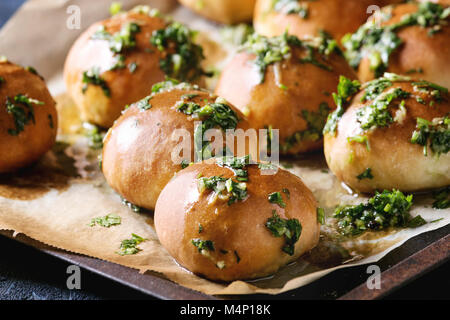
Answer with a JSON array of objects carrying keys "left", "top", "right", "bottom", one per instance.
[{"left": 179, "top": 0, "right": 256, "bottom": 24}]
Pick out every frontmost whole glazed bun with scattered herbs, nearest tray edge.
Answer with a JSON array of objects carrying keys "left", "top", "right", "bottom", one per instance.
[{"left": 155, "top": 157, "right": 320, "bottom": 281}]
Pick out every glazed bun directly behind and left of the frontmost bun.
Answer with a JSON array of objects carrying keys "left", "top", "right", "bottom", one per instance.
[{"left": 102, "top": 82, "right": 253, "bottom": 209}]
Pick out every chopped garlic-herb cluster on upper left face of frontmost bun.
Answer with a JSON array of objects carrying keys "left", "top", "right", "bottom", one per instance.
[{"left": 197, "top": 176, "right": 247, "bottom": 205}]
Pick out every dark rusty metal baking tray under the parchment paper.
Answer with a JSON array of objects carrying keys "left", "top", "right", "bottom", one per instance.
[{"left": 0, "top": 225, "right": 450, "bottom": 300}]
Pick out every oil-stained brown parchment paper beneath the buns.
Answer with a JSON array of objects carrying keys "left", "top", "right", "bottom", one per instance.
[{"left": 0, "top": 0, "right": 450, "bottom": 294}]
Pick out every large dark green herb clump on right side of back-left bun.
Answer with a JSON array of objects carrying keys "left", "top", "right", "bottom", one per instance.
[{"left": 150, "top": 22, "right": 211, "bottom": 81}]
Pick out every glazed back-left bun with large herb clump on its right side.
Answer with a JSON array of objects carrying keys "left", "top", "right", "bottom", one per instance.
[{"left": 64, "top": 7, "right": 210, "bottom": 127}]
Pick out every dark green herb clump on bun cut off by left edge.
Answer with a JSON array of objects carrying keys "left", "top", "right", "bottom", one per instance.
[{"left": 5, "top": 94, "right": 44, "bottom": 136}]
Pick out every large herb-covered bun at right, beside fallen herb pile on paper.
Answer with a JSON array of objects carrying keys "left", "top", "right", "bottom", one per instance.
[{"left": 324, "top": 74, "right": 450, "bottom": 192}]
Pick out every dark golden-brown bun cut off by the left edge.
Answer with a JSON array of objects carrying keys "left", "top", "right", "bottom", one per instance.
[{"left": 0, "top": 62, "right": 58, "bottom": 173}]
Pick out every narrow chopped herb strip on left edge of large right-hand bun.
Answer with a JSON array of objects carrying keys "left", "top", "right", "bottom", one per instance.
[{"left": 323, "top": 76, "right": 361, "bottom": 135}]
